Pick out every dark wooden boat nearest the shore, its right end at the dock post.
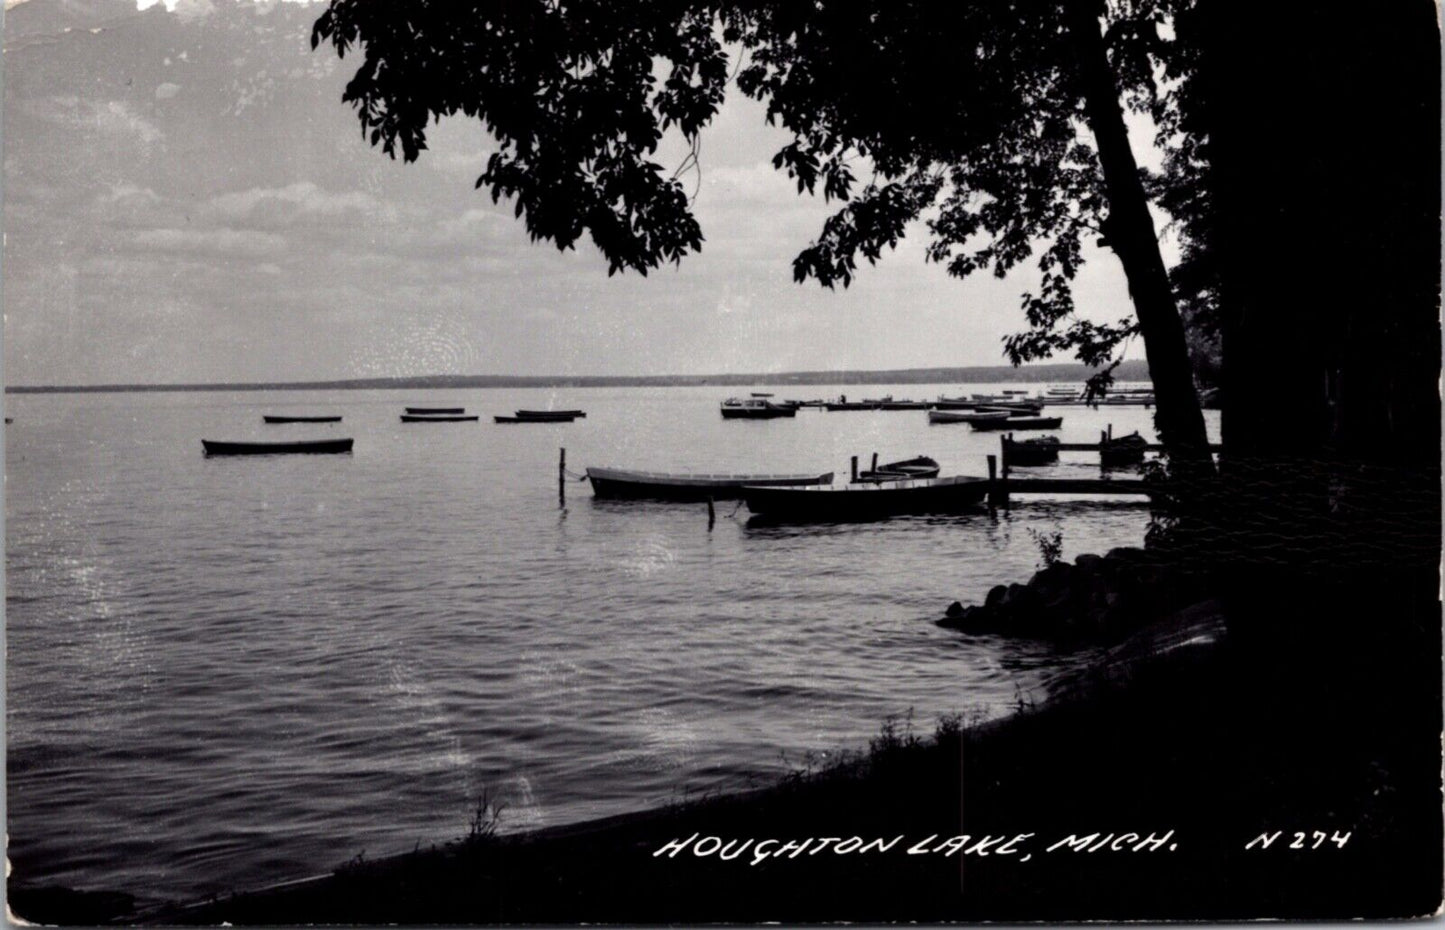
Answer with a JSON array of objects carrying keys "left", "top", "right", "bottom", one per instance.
[{"left": 743, "top": 475, "right": 988, "bottom": 523}]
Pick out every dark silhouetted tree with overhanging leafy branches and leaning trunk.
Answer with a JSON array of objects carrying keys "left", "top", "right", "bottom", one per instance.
[{"left": 312, "top": 0, "right": 1209, "bottom": 469}]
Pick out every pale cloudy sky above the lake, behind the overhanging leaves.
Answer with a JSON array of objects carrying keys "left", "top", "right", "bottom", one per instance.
[{"left": 0, "top": 0, "right": 1140, "bottom": 384}]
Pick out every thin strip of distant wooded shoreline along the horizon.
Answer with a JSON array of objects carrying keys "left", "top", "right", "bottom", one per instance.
[{"left": 4, "top": 361, "right": 1149, "bottom": 394}]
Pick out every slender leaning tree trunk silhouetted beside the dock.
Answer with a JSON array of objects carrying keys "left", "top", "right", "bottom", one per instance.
[{"left": 1064, "top": 0, "right": 1214, "bottom": 478}]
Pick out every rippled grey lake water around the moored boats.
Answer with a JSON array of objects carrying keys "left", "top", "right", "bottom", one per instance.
[{"left": 4, "top": 386, "right": 1218, "bottom": 900}]
